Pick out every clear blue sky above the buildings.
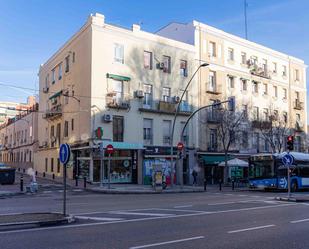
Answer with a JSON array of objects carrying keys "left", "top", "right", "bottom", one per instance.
[{"left": 0, "top": 0, "right": 309, "bottom": 106}]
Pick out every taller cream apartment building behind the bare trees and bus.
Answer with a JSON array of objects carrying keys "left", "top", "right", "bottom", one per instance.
[{"left": 157, "top": 21, "right": 307, "bottom": 181}]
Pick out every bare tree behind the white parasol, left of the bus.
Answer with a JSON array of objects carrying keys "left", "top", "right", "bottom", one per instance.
[{"left": 217, "top": 108, "right": 246, "bottom": 182}]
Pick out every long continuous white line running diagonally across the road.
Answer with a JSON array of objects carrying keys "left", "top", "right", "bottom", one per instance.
[{"left": 0, "top": 203, "right": 297, "bottom": 234}]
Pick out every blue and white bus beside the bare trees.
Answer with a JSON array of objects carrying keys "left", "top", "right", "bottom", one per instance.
[{"left": 249, "top": 152, "right": 309, "bottom": 191}]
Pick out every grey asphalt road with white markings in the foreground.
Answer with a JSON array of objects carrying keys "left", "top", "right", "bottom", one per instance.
[{"left": 0, "top": 191, "right": 309, "bottom": 249}]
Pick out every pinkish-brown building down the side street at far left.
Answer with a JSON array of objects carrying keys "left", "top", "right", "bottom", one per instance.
[{"left": 0, "top": 104, "right": 38, "bottom": 170}]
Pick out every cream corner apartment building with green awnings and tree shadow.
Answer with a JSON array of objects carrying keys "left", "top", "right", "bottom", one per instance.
[{"left": 35, "top": 14, "right": 199, "bottom": 184}]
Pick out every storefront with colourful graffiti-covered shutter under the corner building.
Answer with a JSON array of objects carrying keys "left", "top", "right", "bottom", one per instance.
[{"left": 143, "top": 146, "right": 177, "bottom": 185}]
